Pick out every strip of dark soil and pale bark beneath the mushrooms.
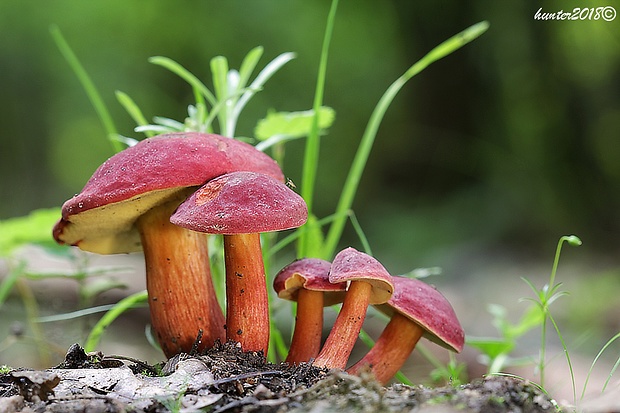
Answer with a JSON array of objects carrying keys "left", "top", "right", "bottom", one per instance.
[{"left": 0, "top": 342, "right": 560, "bottom": 413}]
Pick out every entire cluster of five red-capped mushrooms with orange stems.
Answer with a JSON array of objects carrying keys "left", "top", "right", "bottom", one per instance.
[{"left": 53, "top": 132, "right": 464, "bottom": 383}]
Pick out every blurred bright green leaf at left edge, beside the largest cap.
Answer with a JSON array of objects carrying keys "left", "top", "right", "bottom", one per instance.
[{"left": 0, "top": 208, "right": 61, "bottom": 256}]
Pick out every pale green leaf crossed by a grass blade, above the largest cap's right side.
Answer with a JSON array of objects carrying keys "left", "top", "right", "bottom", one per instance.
[{"left": 254, "top": 106, "right": 336, "bottom": 141}]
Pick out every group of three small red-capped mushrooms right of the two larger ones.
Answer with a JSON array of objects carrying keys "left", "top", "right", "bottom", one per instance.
[{"left": 274, "top": 248, "right": 465, "bottom": 384}]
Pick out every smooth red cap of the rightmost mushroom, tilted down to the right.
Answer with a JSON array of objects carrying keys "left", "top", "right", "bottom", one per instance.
[{"left": 377, "top": 276, "right": 465, "bottom": 352}]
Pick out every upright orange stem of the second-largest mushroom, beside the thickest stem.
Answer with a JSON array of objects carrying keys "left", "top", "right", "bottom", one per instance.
[{"left": 224, "top": 233, "right": 269, "bottom": 355}]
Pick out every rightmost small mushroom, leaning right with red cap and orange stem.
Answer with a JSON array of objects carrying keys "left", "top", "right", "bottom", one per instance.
[{"left": 347, "top": 277, "right": 465, "bottom": 384}]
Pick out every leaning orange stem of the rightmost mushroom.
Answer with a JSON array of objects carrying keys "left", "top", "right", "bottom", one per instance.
[{"left": 347, "top": 313, "right": 424, "bottom": 385}]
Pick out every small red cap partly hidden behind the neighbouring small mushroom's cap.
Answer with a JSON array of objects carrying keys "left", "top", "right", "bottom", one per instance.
[{"left": 273, "top": 258, "right": 347, "bottom": 306}]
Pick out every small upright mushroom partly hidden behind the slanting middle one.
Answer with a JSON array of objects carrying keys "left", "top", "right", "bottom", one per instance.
[{"left": 273, "top": 258, "right": 346, "bottom": 363}]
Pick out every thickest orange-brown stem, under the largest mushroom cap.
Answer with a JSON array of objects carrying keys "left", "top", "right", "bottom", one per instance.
[{"left": 136, "top": 201, "right": 225, "bottom": 357}]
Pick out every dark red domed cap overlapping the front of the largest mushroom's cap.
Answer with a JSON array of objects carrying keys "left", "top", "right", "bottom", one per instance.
[{"left": 170, "top": 172, "right": 308, "bottom": 235}]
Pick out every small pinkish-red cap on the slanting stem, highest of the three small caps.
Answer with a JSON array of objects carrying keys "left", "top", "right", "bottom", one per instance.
[{"left": 329, "top": 247, "right": 394, "bottom": 304}]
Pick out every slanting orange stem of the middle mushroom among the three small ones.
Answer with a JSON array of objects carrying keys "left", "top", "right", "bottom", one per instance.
[{"left": 313, "top": 281, "right": 373, "bottom": 369}]
